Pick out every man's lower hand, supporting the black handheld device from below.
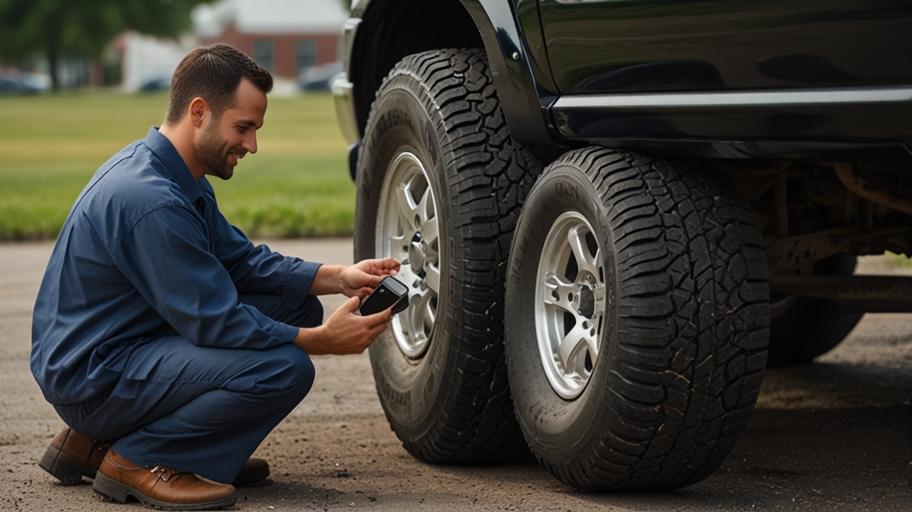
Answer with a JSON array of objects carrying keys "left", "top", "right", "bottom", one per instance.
[{"left": 294, "top": 296, "right": 390, "bottom": 356}]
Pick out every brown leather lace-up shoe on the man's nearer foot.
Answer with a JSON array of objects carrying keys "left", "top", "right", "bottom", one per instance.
[{"left": 92, "top": 450, "right": 237, "bottom": 510}]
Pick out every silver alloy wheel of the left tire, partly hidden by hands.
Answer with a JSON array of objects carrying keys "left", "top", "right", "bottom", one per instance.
[{"left": 375, "top": 151, "right": 440, "bottom": 359}]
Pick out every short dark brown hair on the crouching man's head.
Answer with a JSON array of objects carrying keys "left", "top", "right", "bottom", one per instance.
[{"left": 165, "top": 44, "right": 272, "bottom": 125}]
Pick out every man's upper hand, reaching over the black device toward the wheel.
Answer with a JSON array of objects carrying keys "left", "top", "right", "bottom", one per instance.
[{"left": 310, "top": 258, "right": 399, "bottom": 298}]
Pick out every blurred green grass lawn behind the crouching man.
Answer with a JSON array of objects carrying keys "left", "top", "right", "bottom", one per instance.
[{"left": 0, "top": 92, "right": 355, "bottom": 240}]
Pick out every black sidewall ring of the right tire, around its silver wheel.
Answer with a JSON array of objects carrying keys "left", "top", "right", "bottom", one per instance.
[{"left": 506, "top": 164, "right": 618, "bottom": 464}]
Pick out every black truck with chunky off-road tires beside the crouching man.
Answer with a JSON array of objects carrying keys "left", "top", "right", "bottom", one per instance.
[{"left": 333, "top": 0, "right": 912, "bottom": 491}]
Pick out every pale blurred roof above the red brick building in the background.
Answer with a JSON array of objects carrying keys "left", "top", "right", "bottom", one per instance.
[{"left": 194, "top": 0, "right": 348, "bottom": 37}]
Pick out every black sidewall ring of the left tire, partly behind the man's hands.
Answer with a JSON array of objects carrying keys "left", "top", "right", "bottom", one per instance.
[{"left": 355, "top": 81, "right": 455, "bottom": 441}]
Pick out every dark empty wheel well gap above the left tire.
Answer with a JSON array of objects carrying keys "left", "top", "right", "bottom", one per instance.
[{"left": 349, "top": 0, "right": 484, "bottom": 134}]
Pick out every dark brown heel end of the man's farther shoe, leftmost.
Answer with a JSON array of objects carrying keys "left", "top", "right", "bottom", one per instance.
[{"left": 38, "top": 427, "right": 111, "bottom": 485}]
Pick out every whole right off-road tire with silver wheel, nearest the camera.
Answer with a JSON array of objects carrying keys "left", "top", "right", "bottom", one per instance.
[{"left": 505, "top": 148, "right": 769, "bottom": 491}]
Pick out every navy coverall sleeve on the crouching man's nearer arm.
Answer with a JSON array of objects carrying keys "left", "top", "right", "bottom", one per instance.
[{"left": 114, "top": 205, "right": 298, "bottom": 349}]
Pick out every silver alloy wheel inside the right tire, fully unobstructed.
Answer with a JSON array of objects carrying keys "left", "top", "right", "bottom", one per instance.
[{"left": 535, "top": 212, "right": 605, "bottom": 400}]
